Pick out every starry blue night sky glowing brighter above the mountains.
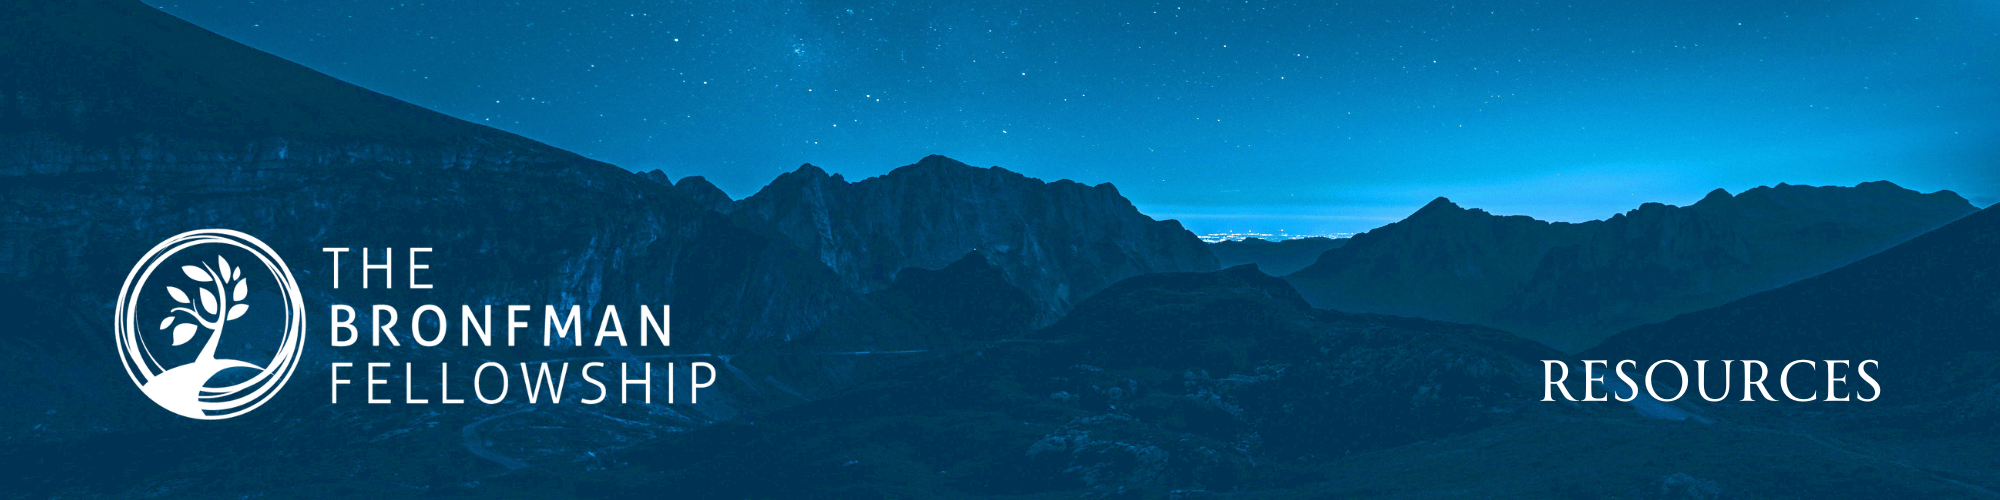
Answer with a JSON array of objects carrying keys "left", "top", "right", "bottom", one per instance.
[{"left": 148, "top": 0, "right": 2000, "bottom": 232}]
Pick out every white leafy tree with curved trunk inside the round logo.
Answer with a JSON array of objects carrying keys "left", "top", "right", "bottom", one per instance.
[{"left": 140, "top": 256, "right": 260, "bottom": 414}]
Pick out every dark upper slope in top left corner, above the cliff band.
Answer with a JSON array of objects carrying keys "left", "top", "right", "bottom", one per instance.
[{"left": 0, "top": 0, "right": 622, "bottom": 172}]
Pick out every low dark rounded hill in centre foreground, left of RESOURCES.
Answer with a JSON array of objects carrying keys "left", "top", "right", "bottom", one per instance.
[{"left": 556, "top": 266, "right": 1570, "bottom": 498}]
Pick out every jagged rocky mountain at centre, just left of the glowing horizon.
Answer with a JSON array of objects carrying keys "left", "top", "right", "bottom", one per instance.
[{"left": 732, "top": 156, "right": 1216, "bottom": 324}]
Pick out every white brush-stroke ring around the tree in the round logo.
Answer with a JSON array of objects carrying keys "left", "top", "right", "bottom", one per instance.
[{"left": 114, "top": 230, "right": 306, "bottom": 420}]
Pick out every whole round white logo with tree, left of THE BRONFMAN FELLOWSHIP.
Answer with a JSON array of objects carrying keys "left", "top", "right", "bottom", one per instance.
[{"left": 114, "top": 230, "right": 306, "bottom": 420}]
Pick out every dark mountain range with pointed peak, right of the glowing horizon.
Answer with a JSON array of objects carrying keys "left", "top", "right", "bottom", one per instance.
[{"left": 1286, "top": 182, "right": 1976, "bottom": 352}]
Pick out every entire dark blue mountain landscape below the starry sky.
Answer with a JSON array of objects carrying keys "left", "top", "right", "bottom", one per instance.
[{"left": 0, "top": 0, "right": 2000, "bottom": 500}]
